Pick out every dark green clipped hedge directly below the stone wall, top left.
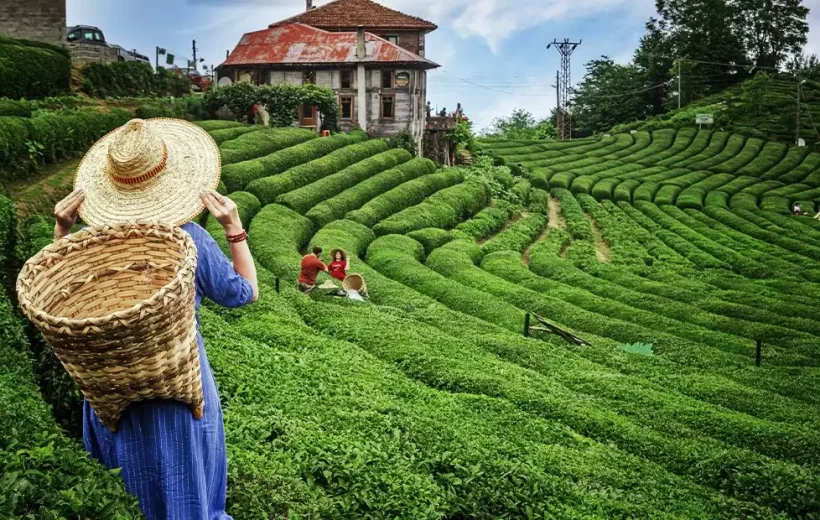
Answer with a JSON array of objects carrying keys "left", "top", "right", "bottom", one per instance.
[{"left": 0, "top": 37, "right": 71, "bottom": 99}]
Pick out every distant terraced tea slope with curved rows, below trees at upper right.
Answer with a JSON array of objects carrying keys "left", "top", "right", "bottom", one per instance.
[{"left": 486, "top": 128, "right": 820, "bottom": 213}]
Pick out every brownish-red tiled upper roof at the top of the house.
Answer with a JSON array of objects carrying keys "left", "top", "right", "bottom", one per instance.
[{"left": 270, "top": 0, "right": 438, "bottom": 31}]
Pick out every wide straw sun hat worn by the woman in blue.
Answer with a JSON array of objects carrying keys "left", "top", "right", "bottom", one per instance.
[{"left": 74, "top": 118, "right": 221, "bottom": 226}]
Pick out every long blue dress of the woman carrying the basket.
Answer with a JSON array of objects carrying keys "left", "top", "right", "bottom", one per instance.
[{"left": 83, "top": 223, "right": 253, "bottom": 520}]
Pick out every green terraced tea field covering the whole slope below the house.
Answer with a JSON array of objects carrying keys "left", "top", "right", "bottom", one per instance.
[{"left": 0, "top": 122, "right": 820, "bottom": 519}]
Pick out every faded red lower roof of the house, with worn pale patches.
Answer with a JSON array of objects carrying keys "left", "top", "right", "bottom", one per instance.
[{"left": 222, "top": 23, "right": 439, "bottom": 69}]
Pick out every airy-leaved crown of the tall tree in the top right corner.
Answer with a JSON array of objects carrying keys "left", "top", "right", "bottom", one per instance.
[{"left": 730, "top": 0, "right": 809, "bottom": 69}]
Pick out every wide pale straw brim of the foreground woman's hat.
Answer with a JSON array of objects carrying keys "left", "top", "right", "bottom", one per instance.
[{"left": 74, "top": 118, "right": 222, "bottom": 226}]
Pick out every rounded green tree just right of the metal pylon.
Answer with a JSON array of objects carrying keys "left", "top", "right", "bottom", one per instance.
[{"left": 572, "top": 56, "right": 651, "bottom": 136}]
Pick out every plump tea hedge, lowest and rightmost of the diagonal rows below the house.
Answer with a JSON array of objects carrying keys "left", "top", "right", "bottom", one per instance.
[{"left": 373, "top": 179, "right": 489, "bottom": 236}]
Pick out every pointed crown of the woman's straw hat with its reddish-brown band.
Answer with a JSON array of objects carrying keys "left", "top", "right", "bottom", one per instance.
[{"left": 108, "top": 119, "right": 168, "bottom": 186}]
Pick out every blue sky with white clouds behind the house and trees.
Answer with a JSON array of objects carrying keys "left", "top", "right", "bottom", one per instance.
[{"left": 67, "top": 0, "right": 820, "bottom": 129}]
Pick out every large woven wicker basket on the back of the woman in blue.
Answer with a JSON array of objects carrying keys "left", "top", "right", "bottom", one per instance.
[{"left": 17, "top": 222, "right": 204, "bottom": 431}]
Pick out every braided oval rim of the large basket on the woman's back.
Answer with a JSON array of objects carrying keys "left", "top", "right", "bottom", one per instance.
[{"left": 17, "top": 221, "right": 197, "bottom": 328}]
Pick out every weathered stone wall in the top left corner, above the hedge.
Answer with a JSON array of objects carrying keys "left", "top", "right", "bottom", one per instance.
[{"left": 0, "top": 0, "right": 66, "bottom": 44}]
